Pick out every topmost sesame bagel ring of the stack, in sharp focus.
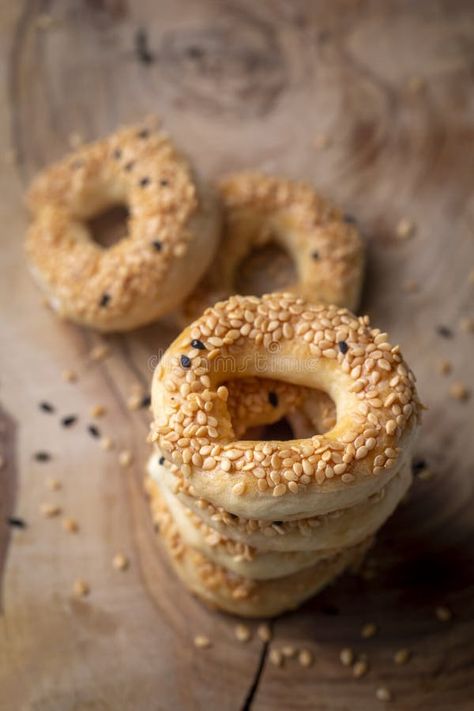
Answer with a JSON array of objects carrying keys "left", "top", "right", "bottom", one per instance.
[{"left": 151, "top": 294, "right": 421, "bottom": 520}]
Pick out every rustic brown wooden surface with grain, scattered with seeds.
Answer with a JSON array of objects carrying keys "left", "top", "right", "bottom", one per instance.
[{"left": 0, "top": 0, "right": 474, "bottom": 711}]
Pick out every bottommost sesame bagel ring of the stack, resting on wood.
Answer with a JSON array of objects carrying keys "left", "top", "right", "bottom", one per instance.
[{"left": 146, "top": 488, "right": 372, "bottom": 617}]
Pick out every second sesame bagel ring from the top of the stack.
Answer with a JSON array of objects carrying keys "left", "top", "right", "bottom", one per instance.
[{"left": 148, "top": 454, "right": 412, "bottom": 556}]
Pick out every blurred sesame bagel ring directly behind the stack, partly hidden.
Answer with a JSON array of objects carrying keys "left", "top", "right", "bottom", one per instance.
[{"left": 183, "top": 172, "right": 364, "bottom": 323}]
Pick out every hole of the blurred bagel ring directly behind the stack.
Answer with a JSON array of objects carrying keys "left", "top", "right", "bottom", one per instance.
[{"left": 235, "top": 242, "right": 297, "bottom": 296}]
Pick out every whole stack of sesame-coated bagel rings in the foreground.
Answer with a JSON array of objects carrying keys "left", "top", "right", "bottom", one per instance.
[{"left": 147, "top": 294, "right": 420, "bottom": 617}]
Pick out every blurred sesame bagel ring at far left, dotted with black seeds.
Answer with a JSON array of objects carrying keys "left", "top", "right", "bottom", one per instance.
[{"left": 26, "top": 121, "right": 220, "bottom": 331}]
